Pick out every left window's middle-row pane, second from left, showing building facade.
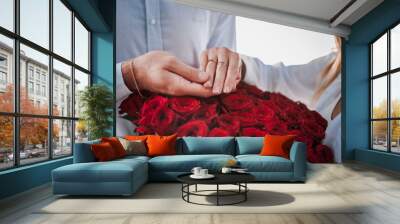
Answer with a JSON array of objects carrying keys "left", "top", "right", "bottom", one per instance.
[{"left": 20, "top": 44, "right": 49, "bottom": 115}]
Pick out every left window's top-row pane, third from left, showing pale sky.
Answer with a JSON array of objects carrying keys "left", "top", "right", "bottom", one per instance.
[{"left": 53, "top": 0, "right": 72, "bottom": 60}]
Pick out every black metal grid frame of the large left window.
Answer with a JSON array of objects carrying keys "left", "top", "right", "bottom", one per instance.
[{"left": 0, "top": 0, "right": 93, "bottom": 172}]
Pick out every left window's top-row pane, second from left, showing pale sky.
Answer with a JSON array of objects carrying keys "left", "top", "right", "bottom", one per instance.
[{"left": 20, "top": 0, "right": 49, "bottom": 48}]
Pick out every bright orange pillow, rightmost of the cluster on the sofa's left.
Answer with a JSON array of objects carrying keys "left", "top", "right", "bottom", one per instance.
[{"left": 147, "top": 134, "right": 178, "bottom": 156}]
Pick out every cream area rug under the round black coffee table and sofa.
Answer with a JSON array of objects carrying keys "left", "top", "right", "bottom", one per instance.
[{"left": 36, "top": 183, "right": 360, "bottom": 214}]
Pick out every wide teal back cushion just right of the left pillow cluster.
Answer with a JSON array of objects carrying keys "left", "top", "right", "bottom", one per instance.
[{"left": 179, "top": 137, "right": 235, "bottom": 155}]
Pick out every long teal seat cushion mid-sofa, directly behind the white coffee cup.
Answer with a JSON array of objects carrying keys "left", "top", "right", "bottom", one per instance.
[{"left": 149, "top": 154, "right": 235, "bottom": 172}]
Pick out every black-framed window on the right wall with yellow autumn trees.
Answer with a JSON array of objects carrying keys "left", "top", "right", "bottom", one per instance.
[{"left": 370, "top": 24, "right": 400, "bottom": 153}]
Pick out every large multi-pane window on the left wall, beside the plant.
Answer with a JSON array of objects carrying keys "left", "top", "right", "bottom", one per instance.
[{"left": 0, "top": 0, "right": 91, "bottom": 170}]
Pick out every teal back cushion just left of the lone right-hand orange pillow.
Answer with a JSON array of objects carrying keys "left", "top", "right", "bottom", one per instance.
[{"left": 236, "top": 137, "right": 264, "bottom": 155}]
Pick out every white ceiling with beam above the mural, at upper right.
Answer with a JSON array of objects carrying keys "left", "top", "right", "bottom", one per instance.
[{"left": 175, "top": 0, "right": 383, "bottom": 37}]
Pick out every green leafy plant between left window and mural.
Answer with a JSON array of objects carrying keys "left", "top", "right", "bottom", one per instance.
[{"left": 79, "top": 84, "right": 113, "bottom": 139}]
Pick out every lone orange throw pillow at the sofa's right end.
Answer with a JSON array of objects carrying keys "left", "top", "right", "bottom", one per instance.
[{"left": 260, "top": 135, "right": 296, "bottom": 159}]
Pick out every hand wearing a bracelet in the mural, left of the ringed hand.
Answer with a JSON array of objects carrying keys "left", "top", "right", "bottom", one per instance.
[{"left": 121, "top": 51, "right": 213, "bottom": 97}]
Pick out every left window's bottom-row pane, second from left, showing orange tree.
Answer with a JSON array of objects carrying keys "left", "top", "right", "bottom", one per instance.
[{"left": 19, "top": 117, "right": 49, "bottom": 164}]
